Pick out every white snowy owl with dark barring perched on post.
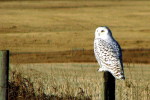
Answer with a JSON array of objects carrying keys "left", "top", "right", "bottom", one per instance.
[{"left": 94, "top": 27, "right": 125, "bottom": 80}]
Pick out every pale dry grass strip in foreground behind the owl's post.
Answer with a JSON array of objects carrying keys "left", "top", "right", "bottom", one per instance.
[{"left": 10, "top": 63, "right": 150, "bottom": 100}]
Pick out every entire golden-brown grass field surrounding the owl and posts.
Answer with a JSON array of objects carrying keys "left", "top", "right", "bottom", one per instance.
[{"left": 0, "top": 0, "right": 150, "bottom": 100}]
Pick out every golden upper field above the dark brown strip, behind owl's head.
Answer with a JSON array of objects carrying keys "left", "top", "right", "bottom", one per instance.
[{"left": 0, "top": 0, "right": 150, "bottom": 52}]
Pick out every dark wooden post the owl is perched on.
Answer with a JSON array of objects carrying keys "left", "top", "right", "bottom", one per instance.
[{"left": 104, "top": 72, "right": 115, "bottom": 100}]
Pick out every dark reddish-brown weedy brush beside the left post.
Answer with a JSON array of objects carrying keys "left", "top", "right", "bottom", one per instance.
[{"left": 8, "top": 71, "right": 91, "bottom": 100}]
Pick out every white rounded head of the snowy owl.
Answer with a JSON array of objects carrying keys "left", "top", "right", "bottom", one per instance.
[{"left": 95, "top": 26, "right": 112, "bottom": 39}]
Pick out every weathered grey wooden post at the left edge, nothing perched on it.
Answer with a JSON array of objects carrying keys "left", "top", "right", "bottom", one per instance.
[{"left": 0, "top": 50, "right": 9, "bottom": 100}]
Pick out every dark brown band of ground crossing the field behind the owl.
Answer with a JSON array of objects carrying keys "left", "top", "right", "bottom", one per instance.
[{"left": 10, "top": 49, "right": 150, "bottom": 63}]
